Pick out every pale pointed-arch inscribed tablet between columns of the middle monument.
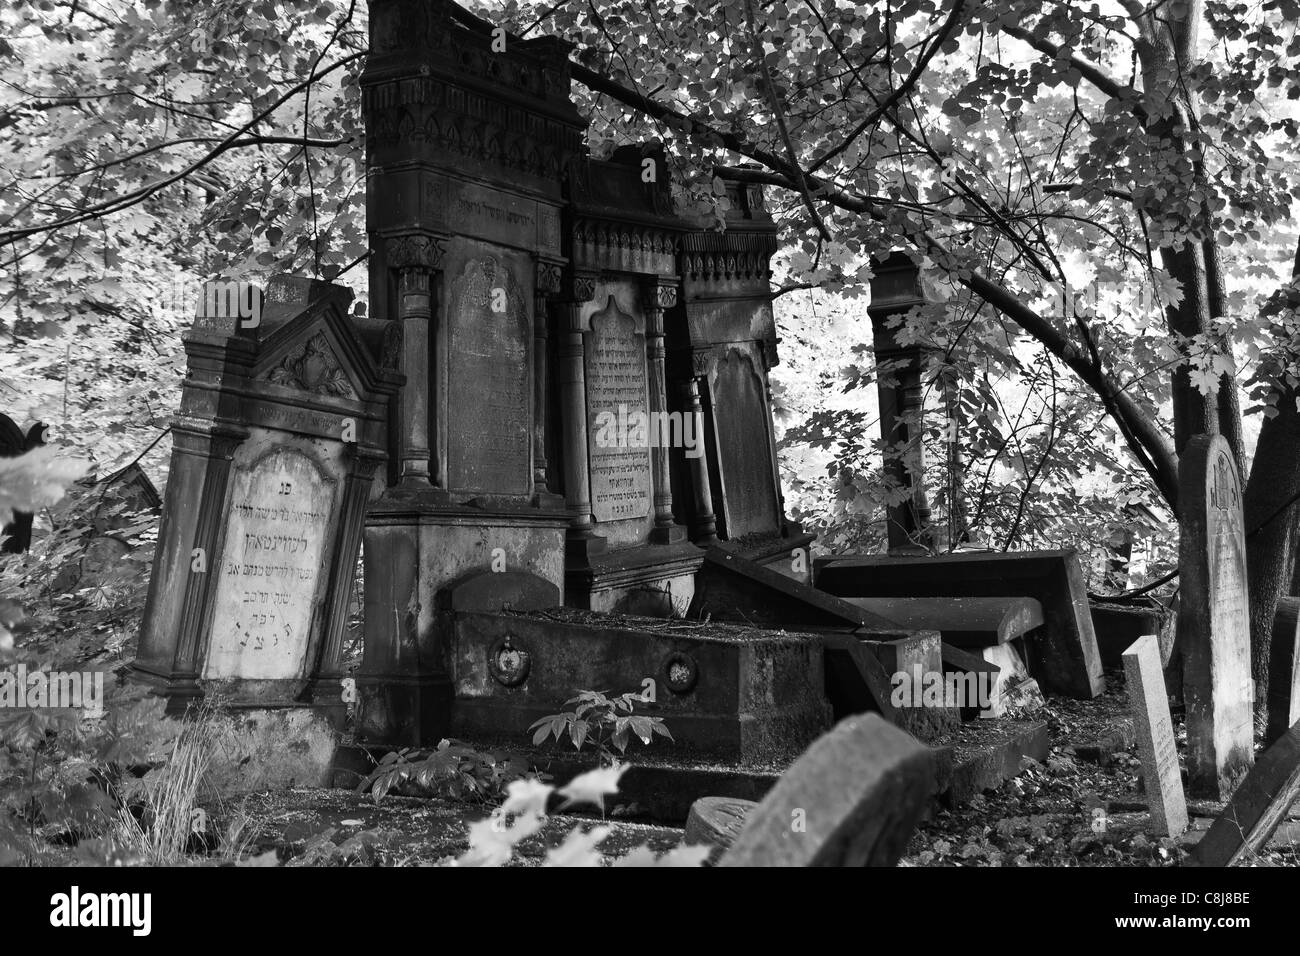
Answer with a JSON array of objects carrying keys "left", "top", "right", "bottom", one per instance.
[{"left": 584, "top": 295, "right": 658, "bottom": 522}]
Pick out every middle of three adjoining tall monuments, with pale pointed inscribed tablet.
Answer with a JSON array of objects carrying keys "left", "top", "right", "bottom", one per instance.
[{"left": 554, "top": 146, "right": 702, "bottom": 617}]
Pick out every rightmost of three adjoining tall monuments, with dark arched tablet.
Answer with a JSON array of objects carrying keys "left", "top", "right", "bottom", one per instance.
[{"left": 667, "top": 182, "right": 813, "bottom": 567}]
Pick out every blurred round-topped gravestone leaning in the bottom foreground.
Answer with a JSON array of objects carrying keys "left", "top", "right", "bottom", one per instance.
[{"left": 719, "top": 714, "right": 936, "bottom": 866}]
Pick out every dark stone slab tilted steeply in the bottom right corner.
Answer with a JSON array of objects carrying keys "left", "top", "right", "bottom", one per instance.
[{"left": 1192, "top": 726, "right": 1300, "bottom": 866}]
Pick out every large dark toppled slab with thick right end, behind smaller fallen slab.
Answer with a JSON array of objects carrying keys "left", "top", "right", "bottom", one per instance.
[{"left": 814, "top": 550, "right": 1104, "bottom": 700}]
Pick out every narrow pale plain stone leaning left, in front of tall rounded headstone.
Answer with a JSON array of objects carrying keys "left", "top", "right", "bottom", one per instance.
[{"left": 1123, "top": 635, "right": 1187, "bottom": 836}]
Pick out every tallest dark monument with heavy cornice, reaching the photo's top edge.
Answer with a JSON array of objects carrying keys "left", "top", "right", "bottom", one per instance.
[{"left": 356, "top": 0, "right": 586, "bottom": 745}]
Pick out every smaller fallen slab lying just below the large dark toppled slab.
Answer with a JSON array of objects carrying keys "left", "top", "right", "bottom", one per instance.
[{"left": 846, "top": 597, "right": 1043, "bottom": 648}]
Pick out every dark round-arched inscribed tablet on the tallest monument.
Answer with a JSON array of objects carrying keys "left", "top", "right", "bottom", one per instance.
[{"left": 447, "top": 255, "right": 533, "bottom": 494}]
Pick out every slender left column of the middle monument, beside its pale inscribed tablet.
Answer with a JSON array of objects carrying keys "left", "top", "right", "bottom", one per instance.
[{"left": 559, "top": 269, "right": 603, "bottom": 550}]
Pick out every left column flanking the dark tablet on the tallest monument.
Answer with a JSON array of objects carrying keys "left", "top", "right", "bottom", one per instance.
[{"left": 386, "top": 235, "right": 445, "bottom": 485}]
